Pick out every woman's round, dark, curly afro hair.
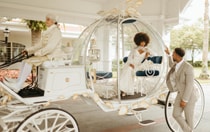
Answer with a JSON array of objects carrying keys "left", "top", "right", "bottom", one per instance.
[{"left": 133, "top": 32, "right": 150, "bottom": 46}]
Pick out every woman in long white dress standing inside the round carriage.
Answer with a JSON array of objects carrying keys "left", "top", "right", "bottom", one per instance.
[{"left": 119, "top": 32, "right": 150, "bottom": 96}]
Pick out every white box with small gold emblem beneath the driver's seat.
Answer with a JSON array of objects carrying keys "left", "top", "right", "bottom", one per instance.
[{"left": 38, "top": 65, "right": 87, "bottom": 100}]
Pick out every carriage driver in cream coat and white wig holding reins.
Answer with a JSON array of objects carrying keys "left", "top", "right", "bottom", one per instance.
[{"left": 3, "top": 14, "right": 62, "bottom": 92}]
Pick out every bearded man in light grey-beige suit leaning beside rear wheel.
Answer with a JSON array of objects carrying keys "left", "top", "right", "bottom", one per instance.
[{"left": 165, "top": 48, "right": 197, "bottom": 132}]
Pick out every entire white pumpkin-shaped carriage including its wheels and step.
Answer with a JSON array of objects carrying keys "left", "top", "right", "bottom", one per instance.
[{"left": 0, "top": 4, "right": 204, "bottom": 132}]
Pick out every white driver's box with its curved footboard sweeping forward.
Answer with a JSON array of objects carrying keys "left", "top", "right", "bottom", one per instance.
[{"left": 0, "top": 65, "right": 88, "bottom": 105}]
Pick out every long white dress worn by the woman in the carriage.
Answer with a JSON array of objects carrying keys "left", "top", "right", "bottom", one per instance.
[{"left": 119, "top": 46, "right": 147, "bottom": 95}]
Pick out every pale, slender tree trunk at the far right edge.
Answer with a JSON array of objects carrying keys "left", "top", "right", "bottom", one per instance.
[{"left": 200, "top": 0, "right": 209, "bottom": 79}]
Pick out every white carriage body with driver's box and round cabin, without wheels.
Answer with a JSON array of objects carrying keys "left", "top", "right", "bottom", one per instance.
[{"left": 0, "top": 16, "right": 167, "bottom": 130}]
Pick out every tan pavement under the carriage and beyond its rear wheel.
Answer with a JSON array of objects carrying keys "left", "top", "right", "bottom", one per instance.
[{"left": 52, "top": 82, "right": 210, "bottom": 132}]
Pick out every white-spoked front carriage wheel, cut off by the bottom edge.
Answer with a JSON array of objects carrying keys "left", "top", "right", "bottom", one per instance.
[{"left": 16, "top": 108, "right": 79, "bottom": 132}]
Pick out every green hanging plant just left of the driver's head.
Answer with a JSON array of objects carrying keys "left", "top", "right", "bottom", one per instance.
[{"left": 25, "top": 20, "right": 46, "bottom": 46}]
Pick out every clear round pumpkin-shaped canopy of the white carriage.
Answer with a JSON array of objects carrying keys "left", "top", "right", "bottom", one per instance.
[{"left": 72, "top": 16, "right": 167, "bottom": 98}]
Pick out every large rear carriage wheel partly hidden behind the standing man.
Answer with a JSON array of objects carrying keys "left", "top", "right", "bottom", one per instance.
[{"left": 165, "top": 80, "right": 205, "bottom": 132}]
